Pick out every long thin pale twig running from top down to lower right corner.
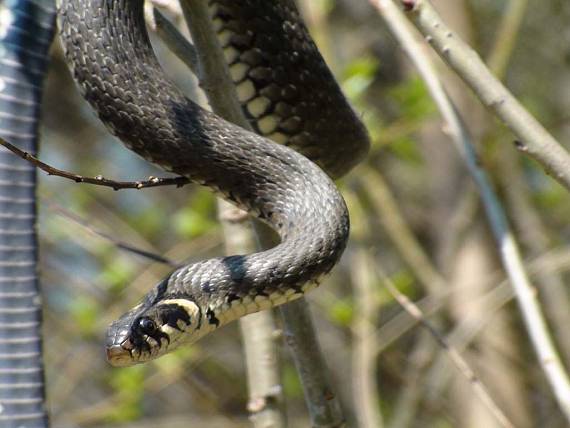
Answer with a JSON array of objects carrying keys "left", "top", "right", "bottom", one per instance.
[{"left": 371, "top": 0, "right": 570, "bottom": 420}]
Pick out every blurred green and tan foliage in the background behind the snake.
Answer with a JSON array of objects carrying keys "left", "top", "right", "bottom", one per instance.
[{"left": 39, "top": 0, "right": 570, "bottom": 427}]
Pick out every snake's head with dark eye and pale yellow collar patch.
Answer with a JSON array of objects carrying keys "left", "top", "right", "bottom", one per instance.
[{"left": 106, "top": 298, "right": 203, "bottom": 367}]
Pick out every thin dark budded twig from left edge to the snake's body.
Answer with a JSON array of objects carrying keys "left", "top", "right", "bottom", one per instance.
[{"left": 0, "top": 138, "right": 190, "bottom": 190}]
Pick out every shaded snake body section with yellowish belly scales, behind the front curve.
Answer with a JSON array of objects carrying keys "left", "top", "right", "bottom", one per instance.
[{"left": 210, "top": 0, "right": 369, "bottom": 178}]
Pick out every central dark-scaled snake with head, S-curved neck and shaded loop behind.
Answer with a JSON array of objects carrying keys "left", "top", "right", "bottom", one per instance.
[{"left": 58, "top": 0, "right": 369, "bottom": 366}]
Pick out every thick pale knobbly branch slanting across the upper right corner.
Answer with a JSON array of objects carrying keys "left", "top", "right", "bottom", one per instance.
[{"left": 394, "top": 0, "right": 570, "bottom": 191}]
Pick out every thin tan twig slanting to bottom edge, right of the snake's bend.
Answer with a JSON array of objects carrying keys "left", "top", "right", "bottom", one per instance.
[{"left": 376, "top": 265, "right": 514, "bottom": 428}]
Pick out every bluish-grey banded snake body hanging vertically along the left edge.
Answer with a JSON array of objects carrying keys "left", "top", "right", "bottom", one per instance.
[{"left": 0, "top": 0, "right": 55, "bottom": 428}]
